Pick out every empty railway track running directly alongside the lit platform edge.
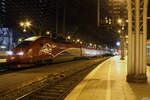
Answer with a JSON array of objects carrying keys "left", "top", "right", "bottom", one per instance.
[{"left": 16, "top": 59, "right": 101, "bottom": 100}]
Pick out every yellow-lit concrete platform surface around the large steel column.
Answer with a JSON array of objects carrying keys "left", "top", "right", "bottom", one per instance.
[{"left": 65, "top": 56, "right": 150, "bottom": 100}]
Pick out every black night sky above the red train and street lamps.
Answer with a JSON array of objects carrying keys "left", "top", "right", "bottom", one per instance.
[{"left": 1, "top": 0, "right": 150, "bottom": 47}]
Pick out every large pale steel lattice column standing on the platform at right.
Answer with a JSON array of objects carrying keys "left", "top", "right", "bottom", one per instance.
[{"left": 127, "top": 0, "right": 148, "bottom": 82}]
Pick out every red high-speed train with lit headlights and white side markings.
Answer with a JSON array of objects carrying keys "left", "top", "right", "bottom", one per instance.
[{"left": 7, "top": 36, "right": 105, "bottom": 68}]
